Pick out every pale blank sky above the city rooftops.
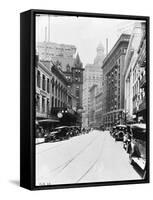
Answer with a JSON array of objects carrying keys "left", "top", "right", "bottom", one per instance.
[{"left": 36, "top": 15, "right": 141, "bottom": 65}]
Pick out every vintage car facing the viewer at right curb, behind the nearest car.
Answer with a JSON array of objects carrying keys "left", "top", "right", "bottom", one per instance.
[{"left": 114, "top": 124, "right": 127, "bottom": 141}]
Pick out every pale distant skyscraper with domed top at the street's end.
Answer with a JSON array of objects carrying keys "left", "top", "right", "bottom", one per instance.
[{"left": 82, "top": 43, "right": 105, "bottom": 127}]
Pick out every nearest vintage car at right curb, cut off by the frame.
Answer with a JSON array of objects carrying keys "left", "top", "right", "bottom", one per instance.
[{"left": 128, "top": 124, "right": 146, "bottom": 176}]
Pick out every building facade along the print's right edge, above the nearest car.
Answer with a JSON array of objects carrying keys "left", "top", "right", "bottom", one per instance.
[{"left": 133, "top": 23, "right": 146, "bottom": 123}]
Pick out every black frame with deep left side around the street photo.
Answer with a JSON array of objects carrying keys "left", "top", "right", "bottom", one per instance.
[{"left": 20, "top": 9, "right": 150, "bottom": 190}]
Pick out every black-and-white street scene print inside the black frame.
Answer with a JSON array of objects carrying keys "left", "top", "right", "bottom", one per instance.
[{"left": 34, "top": 14, "right": 149, "bottom": 186}]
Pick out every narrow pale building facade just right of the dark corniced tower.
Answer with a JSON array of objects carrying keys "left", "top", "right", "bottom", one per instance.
[{"left": 124, "top": 22, "right": 145, "bottom": 123}]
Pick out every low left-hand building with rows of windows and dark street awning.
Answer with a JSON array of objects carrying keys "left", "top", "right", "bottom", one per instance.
[{"left": 35, "top": 56, "right": 81, "bottom": 130}]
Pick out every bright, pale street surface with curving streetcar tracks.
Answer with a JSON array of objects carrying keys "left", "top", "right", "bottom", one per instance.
[{"left": 36, "top": 130, "right": 141, "bottom": 185}]
